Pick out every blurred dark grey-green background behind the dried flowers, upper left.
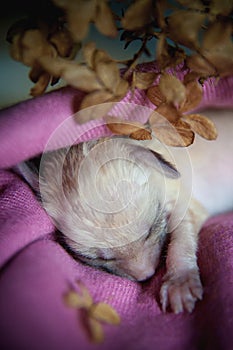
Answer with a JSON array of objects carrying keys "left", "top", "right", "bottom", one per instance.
[{"left": 0, "top": 0, "right": 155, "bottom": 109}]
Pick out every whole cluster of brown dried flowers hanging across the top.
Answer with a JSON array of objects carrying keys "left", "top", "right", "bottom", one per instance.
[{"left": 7, "top": 0, "right": 233, "bottom": 146}]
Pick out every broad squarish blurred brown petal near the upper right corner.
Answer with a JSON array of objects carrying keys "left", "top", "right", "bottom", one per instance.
[{"left": 168, "top": 10, "right": 206, "bottom": 49}]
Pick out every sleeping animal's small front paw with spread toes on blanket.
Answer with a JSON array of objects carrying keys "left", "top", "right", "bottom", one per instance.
[{"left": 160, "top": 269, "right": 203, "bottom": 314}]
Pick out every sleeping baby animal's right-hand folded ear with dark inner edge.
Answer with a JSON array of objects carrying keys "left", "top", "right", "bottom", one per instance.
[{"left": 129, "top": 145, "right": 180, "bottom": 179}]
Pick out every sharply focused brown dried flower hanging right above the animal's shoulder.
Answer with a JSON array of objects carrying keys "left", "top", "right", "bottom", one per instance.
[{"left": 147, "top": 73, "right": 217, "bottom": 146}]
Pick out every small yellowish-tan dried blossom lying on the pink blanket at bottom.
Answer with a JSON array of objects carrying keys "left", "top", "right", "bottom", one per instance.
[{"left": 64, "top": 281, "right": 121, "bottom": 343}]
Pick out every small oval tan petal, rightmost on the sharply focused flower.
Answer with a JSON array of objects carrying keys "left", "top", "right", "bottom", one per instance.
[{"left": 182, "top": 114, "right": 218, "bottom": 140}]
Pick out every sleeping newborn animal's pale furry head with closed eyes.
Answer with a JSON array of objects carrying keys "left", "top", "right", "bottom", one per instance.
[{"left": 40, "top": 138, "right": 179, "bottom": 281}]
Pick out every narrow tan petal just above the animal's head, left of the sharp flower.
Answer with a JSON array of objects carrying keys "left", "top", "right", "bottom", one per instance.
[{"left": 105, "top": 115, "right": 147, "bottom": 136}]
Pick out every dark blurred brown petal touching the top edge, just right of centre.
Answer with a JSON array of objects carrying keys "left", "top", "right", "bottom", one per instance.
[{"left": 121, "top": 0, "right": 153, "bottom": 30}]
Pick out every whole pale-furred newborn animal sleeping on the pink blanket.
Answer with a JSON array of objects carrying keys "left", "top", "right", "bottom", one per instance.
[{"left": 17, "top": 110, "right": 233, "bottom": 313}]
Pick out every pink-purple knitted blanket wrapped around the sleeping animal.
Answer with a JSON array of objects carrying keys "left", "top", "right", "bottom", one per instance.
[{"left": 0, "top": 67, "right": 233, "bottom": 350}]
